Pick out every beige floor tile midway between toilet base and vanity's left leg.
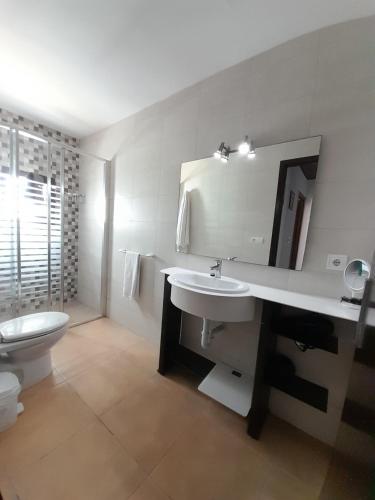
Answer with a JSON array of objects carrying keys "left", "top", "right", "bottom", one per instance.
[{"left": 69, "top": 352, "right": 155, "bottom": 415}]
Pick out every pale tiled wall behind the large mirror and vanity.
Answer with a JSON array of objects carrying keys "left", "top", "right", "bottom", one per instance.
[{"left": 82, "top": 17, "right": 375, "bottom": 442}]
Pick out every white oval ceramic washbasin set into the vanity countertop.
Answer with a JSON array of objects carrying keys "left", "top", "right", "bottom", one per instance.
[{"left": 168, "top": 272, "right": 255, "bottom": 322}]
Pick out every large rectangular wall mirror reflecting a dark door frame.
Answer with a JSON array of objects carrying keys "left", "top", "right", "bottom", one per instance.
[{"left": 176, "top": 136, "right": 321, "bottom": 270}]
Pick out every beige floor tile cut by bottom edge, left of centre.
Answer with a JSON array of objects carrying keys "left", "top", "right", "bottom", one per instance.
[{"left": 14, "top": 422, "right": 145, "bottom": 500}]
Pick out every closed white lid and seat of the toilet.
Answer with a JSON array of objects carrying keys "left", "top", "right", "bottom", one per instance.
[{"left": 0, "top": 312, "right": 69, "bottom": 342}]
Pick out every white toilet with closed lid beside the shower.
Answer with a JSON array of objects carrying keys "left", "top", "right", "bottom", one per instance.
[{"left": 0, "top": 312, "right": 70, "bottom": 389}]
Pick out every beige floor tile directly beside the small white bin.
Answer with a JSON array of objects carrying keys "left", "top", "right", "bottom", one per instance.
[{"left": 0, "top": 384, "right": 95, "bottom": 472}]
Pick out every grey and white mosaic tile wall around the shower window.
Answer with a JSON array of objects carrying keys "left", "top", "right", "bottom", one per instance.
[{"left": 0, "top": 108, "right": 79, "bottom": 312}]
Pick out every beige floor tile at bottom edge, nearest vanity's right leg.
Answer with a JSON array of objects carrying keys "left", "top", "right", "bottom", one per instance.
[{"left": 151, "top": 415, "right": 326, "bottom": 500}]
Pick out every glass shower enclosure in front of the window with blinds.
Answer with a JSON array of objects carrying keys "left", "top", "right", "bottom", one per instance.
[{"left": 0, "top": 125, "right": 110, "bottom": 324}]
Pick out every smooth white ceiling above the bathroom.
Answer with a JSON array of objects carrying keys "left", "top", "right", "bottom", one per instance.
[{"left": 0, "top": 0, "right": 375, "bottom": 137}]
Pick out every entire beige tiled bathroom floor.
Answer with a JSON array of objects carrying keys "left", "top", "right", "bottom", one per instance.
[{"left": 0, "top": 319, "right": 330, "bottom": 500}]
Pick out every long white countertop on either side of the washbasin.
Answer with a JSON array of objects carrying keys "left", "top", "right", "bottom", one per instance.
[{"left": 160, "top": 267, "right": 375, "bottom": 326}]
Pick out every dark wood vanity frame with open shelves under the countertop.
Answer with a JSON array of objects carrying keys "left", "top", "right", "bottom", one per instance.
[{"left": 158, "top": 275, "right": 338, "bottom": 439}]
